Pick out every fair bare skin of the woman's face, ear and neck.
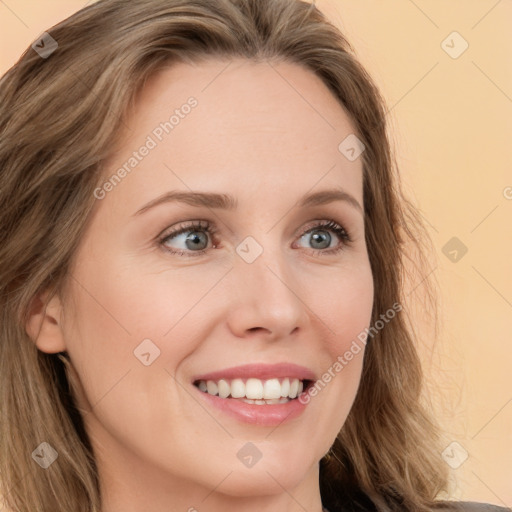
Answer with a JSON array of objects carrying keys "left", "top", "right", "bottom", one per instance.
[{"left": 27, "top": 60, "right": 373, "bottom": 512}]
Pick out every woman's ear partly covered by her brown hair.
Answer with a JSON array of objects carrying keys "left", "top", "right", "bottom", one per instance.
[{"left": 25, "top": 292, "right": 66, "bottom": 354}]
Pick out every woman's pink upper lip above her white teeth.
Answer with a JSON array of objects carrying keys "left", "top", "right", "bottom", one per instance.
[{"left": 192, "top": 363, "right": 316, "bottom": 382}]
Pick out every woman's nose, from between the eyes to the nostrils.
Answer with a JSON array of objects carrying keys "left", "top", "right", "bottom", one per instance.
[{"left": 229, "top": 237, "right": 307, "bottom": 337}]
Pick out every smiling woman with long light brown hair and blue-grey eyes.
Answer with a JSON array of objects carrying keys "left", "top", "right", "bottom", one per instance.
[{"left": 0, "top": 0, "right": 504, "bottom": 512}]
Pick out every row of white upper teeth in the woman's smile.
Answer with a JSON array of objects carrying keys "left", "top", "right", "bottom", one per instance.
[{"left": 198, "top": 378, "right": 304, "bottom": 400}]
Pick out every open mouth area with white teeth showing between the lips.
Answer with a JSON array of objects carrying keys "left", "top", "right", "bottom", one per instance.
[{"left": 194, "top": 377, "right": 313, "bottom": 405}]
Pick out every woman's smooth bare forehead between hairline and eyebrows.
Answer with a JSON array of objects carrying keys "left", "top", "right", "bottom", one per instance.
[{"left": 101, "top": 59, "right": 362, "bottom": 212}]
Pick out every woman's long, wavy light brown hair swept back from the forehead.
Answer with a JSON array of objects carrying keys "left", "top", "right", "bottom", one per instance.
[{"left": 0, "top": 0, "right": 448, "bottom": 512}]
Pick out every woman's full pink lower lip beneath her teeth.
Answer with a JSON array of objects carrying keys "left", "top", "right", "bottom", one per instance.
[{"left": 194, "top": 386, "right": 307, "bottom": 426}]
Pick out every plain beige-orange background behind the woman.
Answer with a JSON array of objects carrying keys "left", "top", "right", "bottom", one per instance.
[{"left": 0, "top": 0, "right": 512, "bottom": 507}]
